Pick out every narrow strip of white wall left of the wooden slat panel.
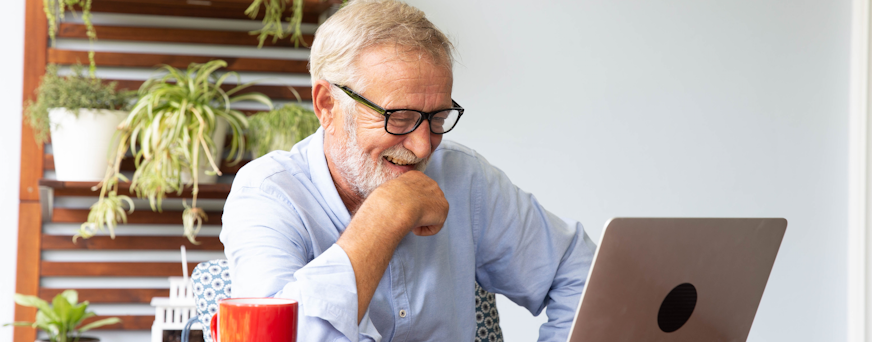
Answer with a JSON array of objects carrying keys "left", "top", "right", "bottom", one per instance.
[{"left": 0, "top": 0, "right": 24, "bottom": 341}]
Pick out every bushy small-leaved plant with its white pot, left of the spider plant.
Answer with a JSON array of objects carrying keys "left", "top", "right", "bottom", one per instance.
[{"left": 24, "top": 65, "right": 134, "bottom": 181}]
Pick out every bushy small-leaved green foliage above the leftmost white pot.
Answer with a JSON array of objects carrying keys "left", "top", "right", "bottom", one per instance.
[{"left": 24, "top": 65, "right": 135, "bottom": 143}]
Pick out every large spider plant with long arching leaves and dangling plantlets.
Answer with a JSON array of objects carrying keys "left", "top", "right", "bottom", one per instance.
[{"left": 76, "top": 60, "right": 272, "bottom": 244}]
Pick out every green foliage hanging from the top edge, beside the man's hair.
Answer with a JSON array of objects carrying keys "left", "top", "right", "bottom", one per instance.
[{"left": 245, "top": 0, "right": 306, "bottom": 48}]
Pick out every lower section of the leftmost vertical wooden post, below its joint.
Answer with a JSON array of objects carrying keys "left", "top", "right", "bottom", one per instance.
[{"left": 14, "top": 201, "right": 42, "bottom": 342}]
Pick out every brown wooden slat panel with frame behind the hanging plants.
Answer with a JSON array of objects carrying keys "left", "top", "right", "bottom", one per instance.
[{"left": 14, "top": 0, "right": 330, "bottom": 342}]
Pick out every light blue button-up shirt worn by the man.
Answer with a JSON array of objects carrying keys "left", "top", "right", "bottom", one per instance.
[{"left": 221, "top": 129, "right": 595, "bottom": 342}]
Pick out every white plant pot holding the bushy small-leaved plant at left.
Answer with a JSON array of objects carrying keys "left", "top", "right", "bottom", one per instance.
[{"left": 48, "top": 108, "right": 129, "bottom": 182}]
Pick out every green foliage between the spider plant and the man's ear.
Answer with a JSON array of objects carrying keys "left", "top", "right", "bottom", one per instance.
[{"left": 247, "top": 104, "right": 321, "bottom": 158}]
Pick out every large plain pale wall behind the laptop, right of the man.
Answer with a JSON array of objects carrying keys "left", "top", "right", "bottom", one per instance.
[{"left": 409, "top": 0, "right": 850, "bottom": 342}]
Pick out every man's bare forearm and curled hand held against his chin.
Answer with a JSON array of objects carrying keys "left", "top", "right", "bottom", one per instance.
[{"left": 336, "top": 171, "right": 448, "bottom": 323}]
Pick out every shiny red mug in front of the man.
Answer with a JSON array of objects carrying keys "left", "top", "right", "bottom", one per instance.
[{"left": 209, "top": 298, "right": 297, "bottom": 342}]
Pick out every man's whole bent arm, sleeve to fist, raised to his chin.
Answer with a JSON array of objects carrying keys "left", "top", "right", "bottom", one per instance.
[{"left": 221, "top": 165, "right": 448, "bottom": 341}]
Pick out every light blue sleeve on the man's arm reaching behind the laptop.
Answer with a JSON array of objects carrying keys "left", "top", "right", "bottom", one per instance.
[{"left": 474, "top": 162, "right": 596, "bottom": 342}]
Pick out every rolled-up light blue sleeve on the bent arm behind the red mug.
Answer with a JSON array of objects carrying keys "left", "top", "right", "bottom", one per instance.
[{"left": 221, "top": 180, "right": 381, "bottom": 342}]
